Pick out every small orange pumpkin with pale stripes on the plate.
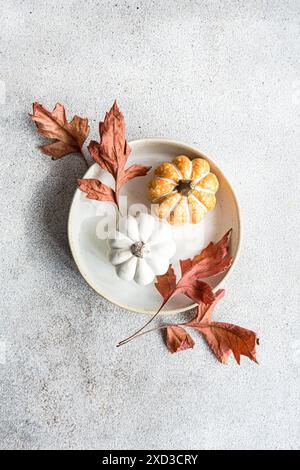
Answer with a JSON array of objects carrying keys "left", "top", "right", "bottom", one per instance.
[{"left": 148, "top": 155, "right": 219, "bottom": 225}]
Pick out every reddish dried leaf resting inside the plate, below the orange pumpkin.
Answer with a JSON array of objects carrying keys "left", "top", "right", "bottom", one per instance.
[{"left": 155, "top": 230, "right": 232, "bottom": 310}]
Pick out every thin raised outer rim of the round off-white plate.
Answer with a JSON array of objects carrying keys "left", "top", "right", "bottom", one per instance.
[{"left": 67, "top": 137, "right": 242, "bottom": 315}]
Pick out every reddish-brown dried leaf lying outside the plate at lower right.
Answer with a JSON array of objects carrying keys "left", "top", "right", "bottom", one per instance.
[{"left": 185, "top": 290, "right": 258, "bottom": 364}]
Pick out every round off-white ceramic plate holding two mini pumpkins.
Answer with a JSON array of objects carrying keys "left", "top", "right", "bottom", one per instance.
[{"left": 68, "top": 139, "right": 241, "bottom": 314}]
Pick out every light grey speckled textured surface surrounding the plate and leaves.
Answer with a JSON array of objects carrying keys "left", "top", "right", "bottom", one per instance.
[{"left": 0, "top": 0, "right": 300, "bottom": 449}]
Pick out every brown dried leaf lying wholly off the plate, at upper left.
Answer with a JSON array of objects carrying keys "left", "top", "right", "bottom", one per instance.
[{"left": 30, "top": 103, "right": 90, "bottom": 160}]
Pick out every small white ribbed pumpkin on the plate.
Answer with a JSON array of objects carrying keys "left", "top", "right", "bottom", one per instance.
[{"left": 108, "top": 213, "right": 176, "bottom": 286}]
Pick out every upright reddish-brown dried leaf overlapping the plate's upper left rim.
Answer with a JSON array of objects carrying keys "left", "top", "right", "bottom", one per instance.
[{"left": 79, "top": 101, "right": 151, "bottom": 205}]
